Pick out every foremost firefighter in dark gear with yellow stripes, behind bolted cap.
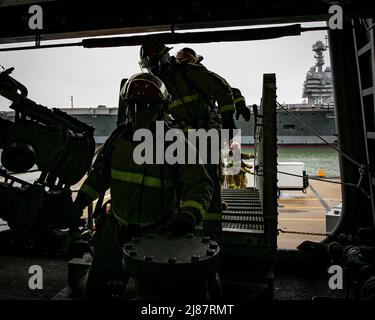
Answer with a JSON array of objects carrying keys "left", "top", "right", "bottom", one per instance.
[{"left": 69, "top": 73, "right": 212, "bottom": 299}]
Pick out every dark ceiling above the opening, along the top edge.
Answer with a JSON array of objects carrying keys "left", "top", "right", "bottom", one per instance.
[{"left": 0, "top": 0, "right": 375, "bottom": 43}]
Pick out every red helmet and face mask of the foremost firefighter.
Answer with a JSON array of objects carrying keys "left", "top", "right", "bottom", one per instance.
[{"left": 121, "top": 73, "right": 167, "bottom": 129}]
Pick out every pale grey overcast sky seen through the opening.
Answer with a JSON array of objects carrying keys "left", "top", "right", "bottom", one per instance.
[{"left": 0, "top": 23, "right": 330, "bottom": 110}]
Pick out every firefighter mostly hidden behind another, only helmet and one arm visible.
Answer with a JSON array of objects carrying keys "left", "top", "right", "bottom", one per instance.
[{"left": 176, "top": 48, "right": 251, "bottom": 121}]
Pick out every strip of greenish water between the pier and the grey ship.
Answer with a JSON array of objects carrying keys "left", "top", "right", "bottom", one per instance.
[{"left": 243, "top": 147, "right": 340, "bottom": 177}]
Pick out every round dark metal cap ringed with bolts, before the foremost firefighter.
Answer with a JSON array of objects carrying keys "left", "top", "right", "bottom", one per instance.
[{"left": 123, "top": 234, "right": 220, "bottom": 282}]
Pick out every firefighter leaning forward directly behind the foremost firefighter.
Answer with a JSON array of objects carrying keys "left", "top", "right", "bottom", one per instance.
[{"left": 140, "top": 39, "right": 235, "bottom": 234}]
